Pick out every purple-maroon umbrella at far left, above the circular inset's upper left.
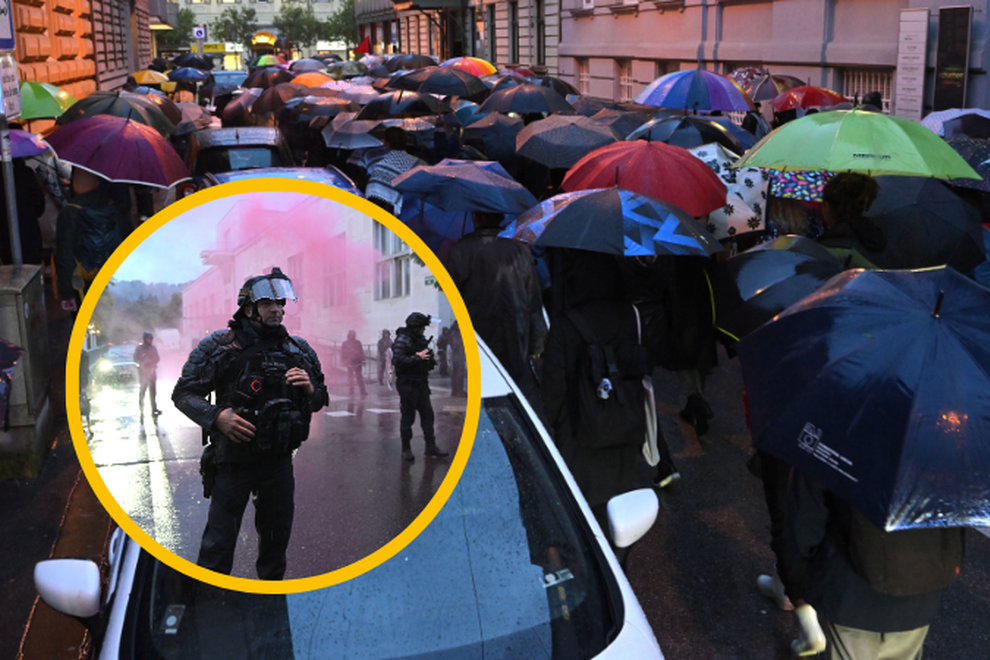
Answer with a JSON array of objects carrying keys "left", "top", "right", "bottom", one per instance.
[{"left": 48, "top": 115, "right": 189, "bottom": 188}]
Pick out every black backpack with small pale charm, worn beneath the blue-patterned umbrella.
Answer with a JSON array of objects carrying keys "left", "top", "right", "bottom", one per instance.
[{"left": 567, "top": 305, "right": 647, "bottom": 449}]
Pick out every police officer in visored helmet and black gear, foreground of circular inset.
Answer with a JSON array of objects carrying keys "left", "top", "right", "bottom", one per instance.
[{"left": 172, "top": 268, "right": 329, "bottom": 580}]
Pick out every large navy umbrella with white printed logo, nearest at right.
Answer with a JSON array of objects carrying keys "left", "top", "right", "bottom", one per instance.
[{"left": 738, "top": 268, "right": 990, "bottom": 531}]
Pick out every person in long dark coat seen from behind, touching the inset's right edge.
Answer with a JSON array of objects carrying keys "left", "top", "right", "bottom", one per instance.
[{"left": 444, "top": 211, "right": 547, "bottom": 414}]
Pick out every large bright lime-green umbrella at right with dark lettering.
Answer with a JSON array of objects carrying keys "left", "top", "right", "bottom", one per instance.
[{"left": 733, "top": 110, "right": 980, "bottom": 179}]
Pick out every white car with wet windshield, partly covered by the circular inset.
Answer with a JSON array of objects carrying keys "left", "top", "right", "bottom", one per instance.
[{"left": 35, "top": 341, "right": 663, "bottom": 660}]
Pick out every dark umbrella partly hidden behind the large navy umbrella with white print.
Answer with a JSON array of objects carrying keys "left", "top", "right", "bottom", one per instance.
[{"left": 711, "top": 236, "right": 845, "bottom": 341}]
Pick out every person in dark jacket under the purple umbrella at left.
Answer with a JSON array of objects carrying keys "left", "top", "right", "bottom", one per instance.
[{"left": 55, "top": 167, "right": 123, "bottom": 312}]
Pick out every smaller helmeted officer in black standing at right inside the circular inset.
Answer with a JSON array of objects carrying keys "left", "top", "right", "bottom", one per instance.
[{"left": 392, "top": 312, "right": 449, "bottom": 461}]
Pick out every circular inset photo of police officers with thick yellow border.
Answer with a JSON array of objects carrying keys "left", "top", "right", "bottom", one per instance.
[{"left": 67, "top": 179, "right": 480, "bottom": 593}]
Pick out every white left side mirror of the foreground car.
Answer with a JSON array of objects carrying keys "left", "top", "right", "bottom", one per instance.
[{"left": 34, "top": 559, "right": 100, "bottom": 619}]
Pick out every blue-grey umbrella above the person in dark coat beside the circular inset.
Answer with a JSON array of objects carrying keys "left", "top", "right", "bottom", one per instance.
[{"left": 392, "top": 159, "right": 537, "bottom": 215}]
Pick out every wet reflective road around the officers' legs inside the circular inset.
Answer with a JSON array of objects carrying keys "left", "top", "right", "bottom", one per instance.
[{"left": 89, "top": 380, "right": 465, "bottom": 578}]
